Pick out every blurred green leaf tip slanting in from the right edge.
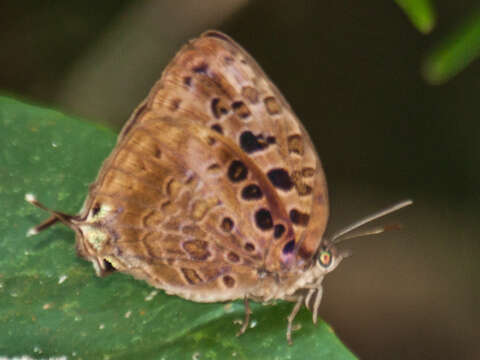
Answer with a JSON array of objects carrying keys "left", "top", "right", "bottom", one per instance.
[{"left": 423, "top": 9, "right": 480, "bottom": 84}]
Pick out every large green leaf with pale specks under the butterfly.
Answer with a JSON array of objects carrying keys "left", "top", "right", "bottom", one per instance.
[{"left": 0, "top": 97, "right": 354, "bottom": 360}]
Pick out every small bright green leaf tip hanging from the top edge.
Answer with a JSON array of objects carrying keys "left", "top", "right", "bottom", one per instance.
[{"left": 395, "top": 0, "right": 436, "bottom": 34}]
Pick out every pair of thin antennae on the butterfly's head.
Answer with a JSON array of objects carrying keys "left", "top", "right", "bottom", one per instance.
[{"left": 330, "top": 199, "right": 413, "bottom": 244}]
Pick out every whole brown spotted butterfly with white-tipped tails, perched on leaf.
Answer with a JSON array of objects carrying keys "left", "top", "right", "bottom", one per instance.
[{"left": 26, "top": 31, "right": 411, "bottom": 343}]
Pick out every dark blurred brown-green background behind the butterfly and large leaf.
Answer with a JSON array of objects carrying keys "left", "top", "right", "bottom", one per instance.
[{"left": 0, "top": 0, "right": 480, "bottom": 359}]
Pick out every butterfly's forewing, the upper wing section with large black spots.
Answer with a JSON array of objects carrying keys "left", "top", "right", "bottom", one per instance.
[{"left": 125, "top": 31, "right": 329, "bottom": 271}]
